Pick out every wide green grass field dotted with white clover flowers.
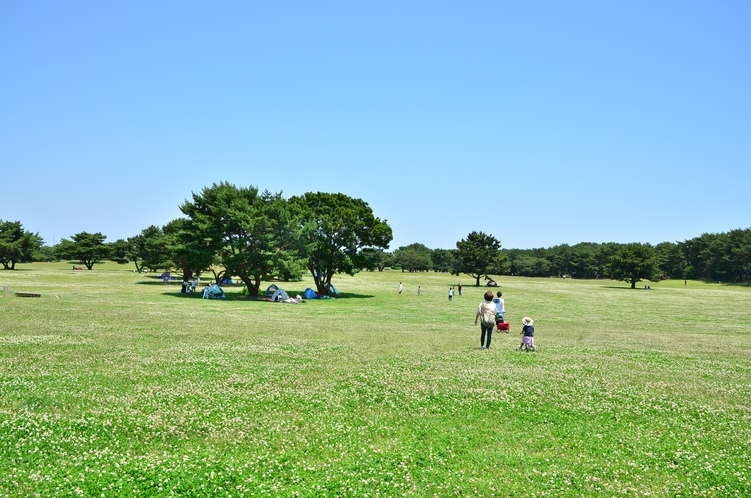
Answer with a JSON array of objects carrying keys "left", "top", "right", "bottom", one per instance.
[{"left": 0, "top": 263, "right": 751, "bottom": 497}]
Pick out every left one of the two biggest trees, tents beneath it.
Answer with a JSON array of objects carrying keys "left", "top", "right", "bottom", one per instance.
[{"left": 180, "top": 182, "right": 299, "bottom": 296}]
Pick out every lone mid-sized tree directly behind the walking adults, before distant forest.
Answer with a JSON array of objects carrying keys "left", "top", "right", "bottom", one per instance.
[{"left": 451, "top": 232, "right": 510, "bottom": 286}]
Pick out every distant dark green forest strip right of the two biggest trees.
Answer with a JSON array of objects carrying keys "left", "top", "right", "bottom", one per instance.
[{"left": 362, "top": 228, "right": 751, "bottom": 287}]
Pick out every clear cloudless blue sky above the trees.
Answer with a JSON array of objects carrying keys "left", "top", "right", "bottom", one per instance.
[{"left": 0, "top": 0, "right": 751, "bottom": 249}]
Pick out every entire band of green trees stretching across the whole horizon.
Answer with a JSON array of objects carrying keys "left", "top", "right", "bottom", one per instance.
[{"left": 0, "top": 182, "right": 751, "bottom": 288}]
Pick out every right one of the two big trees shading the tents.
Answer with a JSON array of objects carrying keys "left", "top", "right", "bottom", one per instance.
[{"left": 290, "top": 192, "right": 393, "bottom": 295}]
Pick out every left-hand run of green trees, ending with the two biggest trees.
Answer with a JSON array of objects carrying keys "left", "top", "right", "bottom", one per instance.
[{"left": 0, "top": 186, "right": 393, "bottom": 296}]
